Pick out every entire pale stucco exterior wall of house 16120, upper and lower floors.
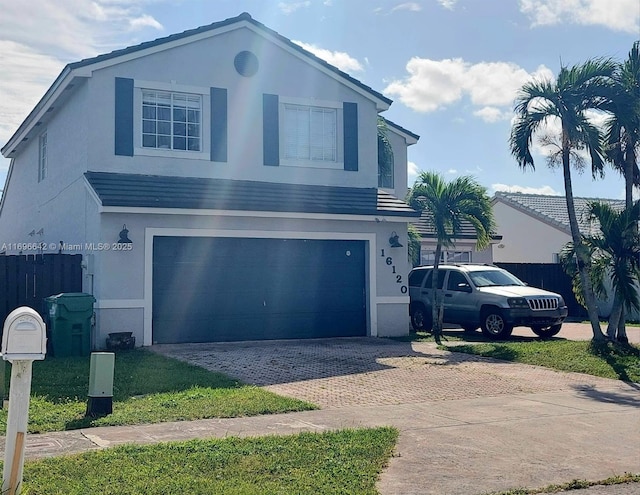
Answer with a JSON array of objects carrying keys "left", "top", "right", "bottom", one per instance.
[{"left": 0, "top": 20, "right": 420, "bottom": 348}]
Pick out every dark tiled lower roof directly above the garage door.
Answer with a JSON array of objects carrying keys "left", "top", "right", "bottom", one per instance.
[{"left": 84, "top": 172, "right": 419, "bottom": 217}]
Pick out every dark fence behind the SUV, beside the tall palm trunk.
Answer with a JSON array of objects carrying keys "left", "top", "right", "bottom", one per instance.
[{"left": 495, "top": 263, "right": 587, "bottom": 318}]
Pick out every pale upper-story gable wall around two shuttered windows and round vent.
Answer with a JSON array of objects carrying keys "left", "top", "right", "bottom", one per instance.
[{"left": 82, "top": 29, "right": 377, "bottom": 187}]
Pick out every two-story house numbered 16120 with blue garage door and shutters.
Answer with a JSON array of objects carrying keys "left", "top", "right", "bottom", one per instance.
[{"left": 0, "top": 13, "right": 418, "bottom": 348}]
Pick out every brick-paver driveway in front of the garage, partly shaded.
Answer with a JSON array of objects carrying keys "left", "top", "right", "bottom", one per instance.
[{"left": 153, "top": 337, "right": 636, "bottom": 409}]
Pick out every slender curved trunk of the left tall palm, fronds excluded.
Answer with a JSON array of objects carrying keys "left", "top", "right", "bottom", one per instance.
[{"left": 562, "top": 139, "right": 605, "bottom": 341}]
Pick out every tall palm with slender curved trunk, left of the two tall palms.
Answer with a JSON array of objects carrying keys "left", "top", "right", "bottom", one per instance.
[{"left": 509, "top": 59, "right": 616, "bottom": 340}]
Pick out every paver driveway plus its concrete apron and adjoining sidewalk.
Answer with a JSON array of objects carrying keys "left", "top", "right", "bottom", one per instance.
[{"left": 0, "top": 326, "right": 640, "bottom": 495}]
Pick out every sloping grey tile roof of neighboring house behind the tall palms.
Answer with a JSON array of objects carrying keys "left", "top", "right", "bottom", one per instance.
[{"left": 493, "top": 191, "right": 625, "bottom": 235}]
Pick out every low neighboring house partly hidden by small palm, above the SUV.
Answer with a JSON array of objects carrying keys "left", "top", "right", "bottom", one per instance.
[{"left": 411, "top": 211, "right": 502, "bottom": 265}]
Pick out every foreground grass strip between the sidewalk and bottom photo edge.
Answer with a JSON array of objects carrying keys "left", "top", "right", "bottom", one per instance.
[{"left": 17, "top": 428, "right": 398, "bottom": 495}]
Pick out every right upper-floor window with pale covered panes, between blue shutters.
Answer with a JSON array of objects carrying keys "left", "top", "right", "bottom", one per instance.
[{"left": 284, "top": 104, "right": 338, "bottom": 162}]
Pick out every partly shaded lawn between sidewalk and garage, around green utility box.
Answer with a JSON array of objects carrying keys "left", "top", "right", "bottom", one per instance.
[{"left": 0, "top": 349, "right": 315, "bottom": 434}]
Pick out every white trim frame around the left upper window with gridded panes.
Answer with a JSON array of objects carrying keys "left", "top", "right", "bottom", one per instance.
[{"left": 133, "top": 79, "right": 211, "bottom": 161}]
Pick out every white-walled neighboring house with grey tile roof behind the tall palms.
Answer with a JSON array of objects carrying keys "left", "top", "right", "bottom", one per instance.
[{"left": 493, "top": 192, "right": 637, "bottom": 317}]
